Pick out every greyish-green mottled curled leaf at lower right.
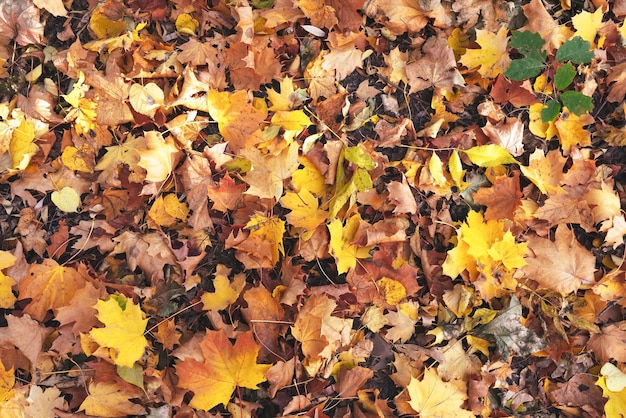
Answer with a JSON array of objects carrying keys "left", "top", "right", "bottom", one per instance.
[{"left": 475, "top": 296, "right": 546, "bottom": 360}]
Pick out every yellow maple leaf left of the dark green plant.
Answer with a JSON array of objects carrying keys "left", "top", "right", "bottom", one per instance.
[{"left": 460, "top": 26, "right": 511, "bottom": 78}]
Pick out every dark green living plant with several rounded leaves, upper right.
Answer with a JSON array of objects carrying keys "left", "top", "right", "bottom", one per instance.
[{"left": 504, "top": 31, "right": 593, "bottom": 123}]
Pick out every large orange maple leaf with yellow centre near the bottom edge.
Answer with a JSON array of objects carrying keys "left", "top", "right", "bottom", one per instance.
[{"left": 176, "top": 330, "right": 271, "bottom": 411}]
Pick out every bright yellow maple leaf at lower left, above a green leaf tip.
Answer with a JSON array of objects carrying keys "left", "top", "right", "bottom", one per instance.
[{"left": 89, "top": 295, "right": 148, "bottom": 367}]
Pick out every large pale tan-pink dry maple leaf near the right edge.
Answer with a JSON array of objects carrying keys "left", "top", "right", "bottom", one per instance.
[{"left": 522, "top": 224, "right": 596, "bottom": 296}]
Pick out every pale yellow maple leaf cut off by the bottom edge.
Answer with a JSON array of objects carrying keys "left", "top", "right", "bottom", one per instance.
[{"left": 407, "top": 368, "right": 474, "bottom": 418}]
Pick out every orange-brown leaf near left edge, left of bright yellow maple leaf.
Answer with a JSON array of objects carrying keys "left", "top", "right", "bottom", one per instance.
[{"left": 19, "top": 258, "right": 89, "bottom": 321}]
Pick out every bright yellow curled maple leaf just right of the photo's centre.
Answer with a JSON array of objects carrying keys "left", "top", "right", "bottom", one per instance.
[{"left": 328, "top": 214, "right": 374, "bottom": 274}]
